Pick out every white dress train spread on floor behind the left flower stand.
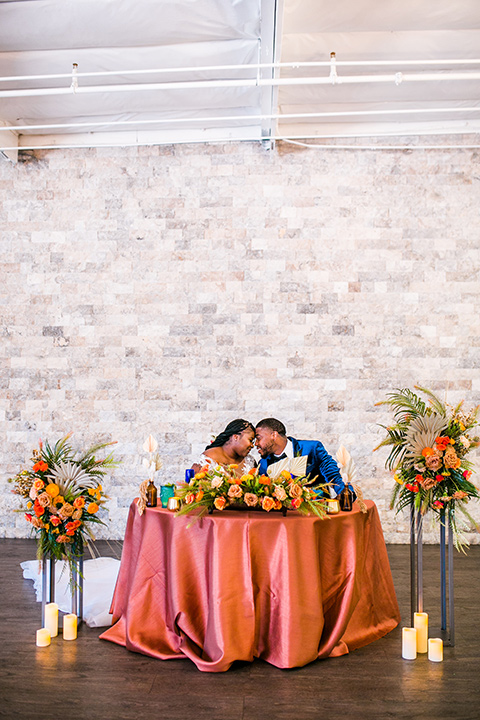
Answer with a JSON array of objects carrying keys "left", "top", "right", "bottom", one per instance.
[{"left": 20, "top": 557, "right": 120, "bottom": 627}]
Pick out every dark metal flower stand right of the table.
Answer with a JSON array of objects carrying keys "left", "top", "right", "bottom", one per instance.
[{"left": 410, "top": 505, "right": 455, "bottom": 646}]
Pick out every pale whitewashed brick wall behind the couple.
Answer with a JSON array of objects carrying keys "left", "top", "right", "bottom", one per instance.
[{"left": 0, "top": 139, "right": 480, "bottom": 542}]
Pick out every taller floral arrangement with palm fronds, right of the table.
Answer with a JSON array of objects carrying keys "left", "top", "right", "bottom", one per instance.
[{"left": 375, "top": 386, "right": 480, "bottom": 546}]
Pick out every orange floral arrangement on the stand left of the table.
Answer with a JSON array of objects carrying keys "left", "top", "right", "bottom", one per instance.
[{"left": 9, "top": 434, "right": 117, "bottom": 567}]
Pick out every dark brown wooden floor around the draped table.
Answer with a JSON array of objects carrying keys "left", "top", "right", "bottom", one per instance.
[{"left": 0, "top": 540, "right": 480, "bottom": 720}]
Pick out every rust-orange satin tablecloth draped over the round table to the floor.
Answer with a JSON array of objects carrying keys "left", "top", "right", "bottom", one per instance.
[{"left": 100, "top": 501, "right": 400, "bottom": 672}]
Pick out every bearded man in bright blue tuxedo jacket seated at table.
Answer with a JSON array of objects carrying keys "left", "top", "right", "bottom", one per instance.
[{"left": 255, "top": 418, "right": 353, "bottom": 495}]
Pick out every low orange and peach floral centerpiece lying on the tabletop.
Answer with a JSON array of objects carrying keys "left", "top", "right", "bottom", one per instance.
[{"left": 177, "top": 464, "right": 326, "bottom": 517}]
